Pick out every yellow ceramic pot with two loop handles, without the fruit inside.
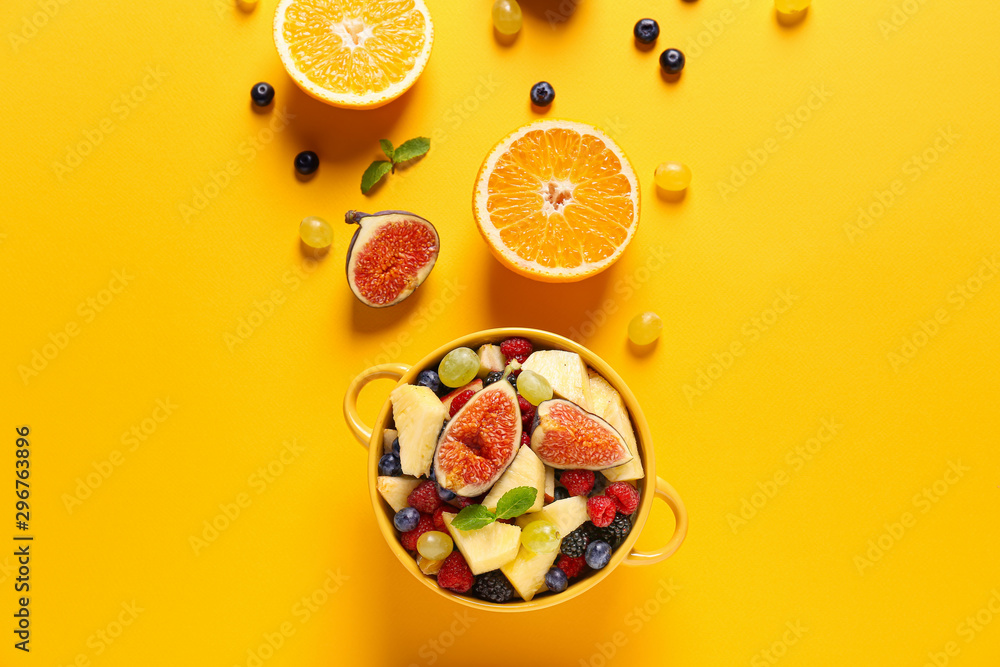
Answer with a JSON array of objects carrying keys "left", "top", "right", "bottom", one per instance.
[{"left": 344, "top": 328, "right": 688, "bottom": 611}]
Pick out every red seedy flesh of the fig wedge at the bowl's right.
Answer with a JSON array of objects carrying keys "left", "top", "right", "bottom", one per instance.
[{"left": 533, "top": 403, "right": 627, "bottom": 467}]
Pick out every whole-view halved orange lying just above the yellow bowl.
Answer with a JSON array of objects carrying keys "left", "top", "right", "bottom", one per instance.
[{"left": 473, "top": 120, "right": 639, "bottom": 282}]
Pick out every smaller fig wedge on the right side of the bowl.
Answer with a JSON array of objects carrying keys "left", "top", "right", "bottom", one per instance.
[{"left": 531, "top": 398, "right": 632, "bottom": 470}]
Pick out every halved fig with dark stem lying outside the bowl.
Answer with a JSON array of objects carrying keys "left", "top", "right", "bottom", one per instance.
[{"left": 345, "top": 211, "right": 441, "bottom": 308}]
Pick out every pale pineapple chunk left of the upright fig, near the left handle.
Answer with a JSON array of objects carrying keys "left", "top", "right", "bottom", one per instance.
[{"left": 389, "top": 384, "right": 447, "bottom": 477}]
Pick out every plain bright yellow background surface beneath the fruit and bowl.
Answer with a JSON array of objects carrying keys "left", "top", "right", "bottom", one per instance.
[{"left": 0, "top": 0, "right": 1000, "bottom": 667}]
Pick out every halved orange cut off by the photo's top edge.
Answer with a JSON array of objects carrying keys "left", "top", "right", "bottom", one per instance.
[{"left": 274, "top": 0, "right": 434, "bottom": 108}]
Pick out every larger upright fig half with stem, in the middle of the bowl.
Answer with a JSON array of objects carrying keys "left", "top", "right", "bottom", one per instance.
[{"left": 434, "top": 382, "right": 521, "bottom": 496}]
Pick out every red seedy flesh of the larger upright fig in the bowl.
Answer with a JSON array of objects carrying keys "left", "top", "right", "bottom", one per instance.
[{"left": 437, "top": 391, "right": 520, "bottom": 489}]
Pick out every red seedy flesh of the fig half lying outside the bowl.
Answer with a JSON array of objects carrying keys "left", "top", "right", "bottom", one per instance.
[{"left": 353, "top": 221, "right": 438, "bottom": 305}]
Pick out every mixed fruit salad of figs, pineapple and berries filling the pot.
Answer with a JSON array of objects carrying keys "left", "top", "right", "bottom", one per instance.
[{"left": 376, "top": 337, "right": 644, "bottom": 603}]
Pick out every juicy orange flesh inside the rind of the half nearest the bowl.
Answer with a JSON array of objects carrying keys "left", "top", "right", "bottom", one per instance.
[{"left": 486, "top": 128, "right": 635, "bottom": 268}]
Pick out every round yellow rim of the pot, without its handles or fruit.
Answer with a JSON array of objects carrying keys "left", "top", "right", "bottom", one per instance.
[{"left": 368, "top": 328, "right": 656, "bottom": 612}]
